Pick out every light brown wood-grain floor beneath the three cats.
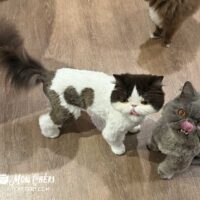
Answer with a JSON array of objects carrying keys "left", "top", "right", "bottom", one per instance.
[{"left": 0, "top": 0, "right": 200, "bottom": 200}]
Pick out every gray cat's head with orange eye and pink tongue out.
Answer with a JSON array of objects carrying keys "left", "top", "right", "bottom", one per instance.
[{"left": 162, "top": 82, "right": 200, "bottom": 135}]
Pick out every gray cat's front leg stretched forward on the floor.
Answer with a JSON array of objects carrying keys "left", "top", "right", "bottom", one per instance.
[{"left": 158, "top": 155, "right": 193, "bottom": 179}]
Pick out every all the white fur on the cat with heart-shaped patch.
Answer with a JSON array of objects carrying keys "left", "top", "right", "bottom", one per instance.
[{"left": 40, "top": 68, "right": 155, "bottom": 155}]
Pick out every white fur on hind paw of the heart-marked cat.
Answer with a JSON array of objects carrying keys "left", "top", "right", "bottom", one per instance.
[{"left": 39, "top": 113, "right": 60, "bottom": 138}]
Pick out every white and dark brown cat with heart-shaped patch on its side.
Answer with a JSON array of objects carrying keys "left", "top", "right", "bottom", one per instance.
[{"left": 0, "top": 21, "right": 164, "bottom": 154}]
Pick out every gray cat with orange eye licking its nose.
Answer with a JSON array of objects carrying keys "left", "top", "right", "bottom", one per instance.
[{"left": 147, "top": 82, "right": 200, "bottom": 179}]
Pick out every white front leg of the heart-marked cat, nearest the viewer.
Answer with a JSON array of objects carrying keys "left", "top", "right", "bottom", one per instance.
[{"left": 102, "top": 125, "right": 126, "bottom": 155}]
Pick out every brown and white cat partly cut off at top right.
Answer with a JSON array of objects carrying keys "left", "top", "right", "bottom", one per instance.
[{"left": 146, "top": 0, "right": 200, "bottom": 47}]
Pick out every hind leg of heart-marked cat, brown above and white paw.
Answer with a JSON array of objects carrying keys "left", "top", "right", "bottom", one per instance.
[{"left": 39, "top": 108, "right": 73, "bottom": 138}]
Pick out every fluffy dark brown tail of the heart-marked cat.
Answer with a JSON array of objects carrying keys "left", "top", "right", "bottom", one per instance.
[{"left": 0, "top": 19, "right": 47, "bottom": 89}]
